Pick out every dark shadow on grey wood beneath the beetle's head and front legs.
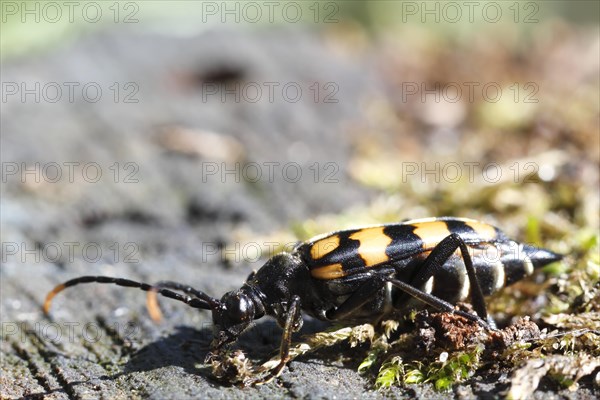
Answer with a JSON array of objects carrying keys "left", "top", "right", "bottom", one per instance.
[{"left": 123, "top": 318, "right": 339, "bottom": 384}]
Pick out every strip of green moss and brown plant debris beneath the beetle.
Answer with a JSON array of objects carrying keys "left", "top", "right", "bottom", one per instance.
[{"left": 210, "top": 304, "right": 600, "bottom": 392}]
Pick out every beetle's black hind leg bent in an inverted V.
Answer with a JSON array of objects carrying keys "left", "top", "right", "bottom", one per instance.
[{"left": 411, "top": 233, "right": 493, "bottom": 324}]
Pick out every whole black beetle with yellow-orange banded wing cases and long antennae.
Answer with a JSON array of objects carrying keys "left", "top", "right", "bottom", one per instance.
[{"left": 44, "top": 217, "right": 562, "bottom": 381}]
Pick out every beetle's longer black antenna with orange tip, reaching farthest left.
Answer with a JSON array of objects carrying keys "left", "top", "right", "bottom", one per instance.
[{"left": 44, "top": 276, "right": 220, "bottom": 314}]
